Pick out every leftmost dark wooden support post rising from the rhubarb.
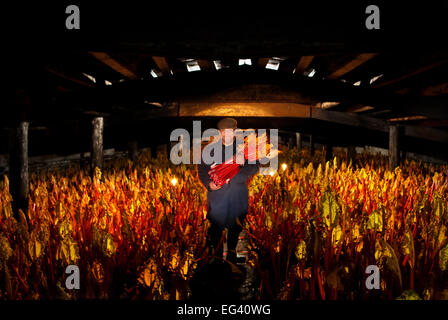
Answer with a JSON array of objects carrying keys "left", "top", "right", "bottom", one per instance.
[{"left": 9, "top": 121, "right": 29, "bottom": 218}]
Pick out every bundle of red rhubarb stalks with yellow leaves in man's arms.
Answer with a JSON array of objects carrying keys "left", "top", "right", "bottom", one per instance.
[{"left": 208, "top": 133, "right": 278, "bottom": 187}]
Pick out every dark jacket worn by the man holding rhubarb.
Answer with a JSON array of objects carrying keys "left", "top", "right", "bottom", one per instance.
[{"left": 198, "top": 141, "right": 260, "bottom": 228}]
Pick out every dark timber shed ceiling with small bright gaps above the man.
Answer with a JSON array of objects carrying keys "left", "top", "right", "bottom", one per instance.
[{"left": 0, "top": 1, "right": 448, "bottom": 157}]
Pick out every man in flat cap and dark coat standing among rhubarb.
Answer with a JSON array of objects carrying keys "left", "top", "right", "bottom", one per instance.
[{"left": 198, "top": 118, "right": 259, "bottom": 263}]
